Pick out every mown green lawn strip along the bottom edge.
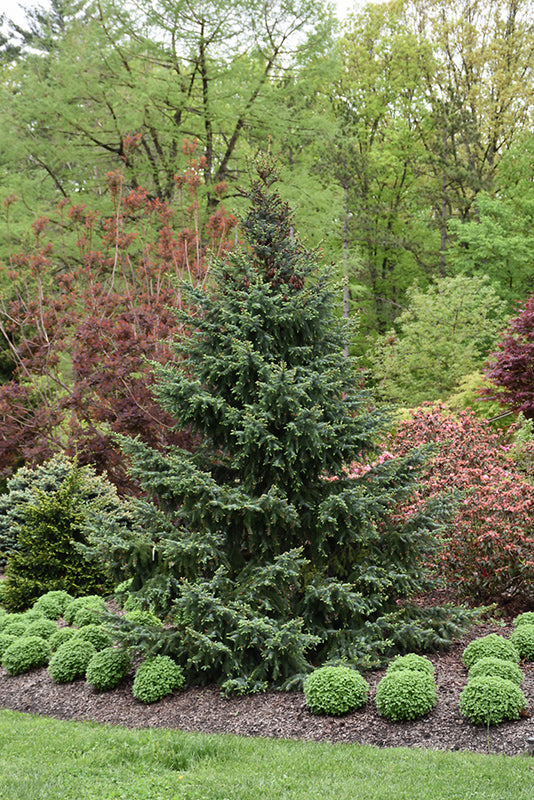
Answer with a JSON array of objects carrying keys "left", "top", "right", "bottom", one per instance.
[{"left": 0, "top": 711, "right": 534, "bottom": 800}]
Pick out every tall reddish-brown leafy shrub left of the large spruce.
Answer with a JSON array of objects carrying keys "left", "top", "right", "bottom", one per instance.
[{"left": 0, "top": 145, "right": 236, "bottom": 491}]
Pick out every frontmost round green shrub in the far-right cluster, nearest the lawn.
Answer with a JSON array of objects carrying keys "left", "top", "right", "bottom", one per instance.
[{"left": 459, "top": 675, "right": 527, "bottom": 725}]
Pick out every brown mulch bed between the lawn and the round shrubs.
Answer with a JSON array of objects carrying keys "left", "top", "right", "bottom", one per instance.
[{"left": 0, "top": 625, "right": 534, "bottom": 755}]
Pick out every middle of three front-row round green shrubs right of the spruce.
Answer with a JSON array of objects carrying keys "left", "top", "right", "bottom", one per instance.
[{"left": 375, "top": 669, "right": 438, "bottom": 722}]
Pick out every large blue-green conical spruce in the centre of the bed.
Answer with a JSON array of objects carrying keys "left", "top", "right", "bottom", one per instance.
[{"left": 95, "top": 165, "right": 474, "bottom": 691}]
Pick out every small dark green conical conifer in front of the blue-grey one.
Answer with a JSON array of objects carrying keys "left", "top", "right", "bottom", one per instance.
[{"left": 2, "top": 468, "right": 114, "bottom": 610}]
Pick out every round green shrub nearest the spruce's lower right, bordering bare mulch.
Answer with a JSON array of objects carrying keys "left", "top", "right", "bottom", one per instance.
[{"left": 304, "top": 666, "right": 369, "bottom": 716}]
